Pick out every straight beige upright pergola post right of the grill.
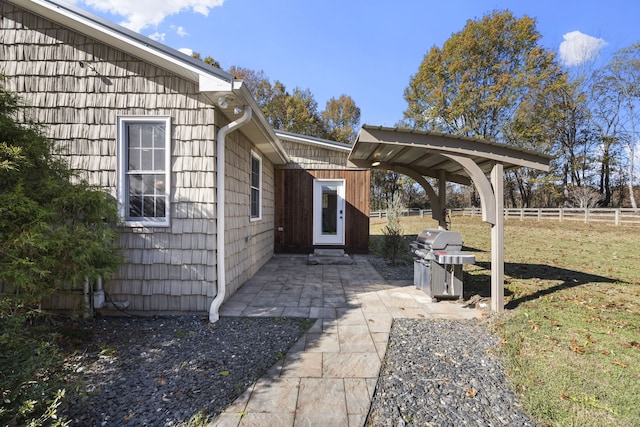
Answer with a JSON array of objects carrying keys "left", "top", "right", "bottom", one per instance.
[{"left": 491, "top": 163, "right": 504, "bottom": 313}]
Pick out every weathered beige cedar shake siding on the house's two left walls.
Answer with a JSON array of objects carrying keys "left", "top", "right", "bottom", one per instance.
[{"left": 0, "top": 1, "right": 274, "bottom": 312}]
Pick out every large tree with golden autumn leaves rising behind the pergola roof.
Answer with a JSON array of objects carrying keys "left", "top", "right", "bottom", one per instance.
[{"left": 404, "top": 11, "right": 566, "bottom": 206}]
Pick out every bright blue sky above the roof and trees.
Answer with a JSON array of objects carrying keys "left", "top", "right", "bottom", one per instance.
[{"left": 67, "top": 0, "right": 640, "bottom": 126}]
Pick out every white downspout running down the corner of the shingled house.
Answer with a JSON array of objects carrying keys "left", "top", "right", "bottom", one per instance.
[{"left": 209, "top": 105, "right": 251, "bottom": 323}]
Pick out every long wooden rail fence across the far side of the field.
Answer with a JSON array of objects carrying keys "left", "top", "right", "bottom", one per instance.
[{"left": 370, "top": 208, "right": 640, "bottom": 225}]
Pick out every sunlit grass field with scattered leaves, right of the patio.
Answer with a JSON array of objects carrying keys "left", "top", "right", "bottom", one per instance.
[{"left": 371, "top": 217, "right": 640, "bottom": 427}]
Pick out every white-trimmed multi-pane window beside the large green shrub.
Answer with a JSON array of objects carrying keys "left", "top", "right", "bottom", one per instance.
[{"left": 117, "top": 117, "right": 171, "bottom": 227}]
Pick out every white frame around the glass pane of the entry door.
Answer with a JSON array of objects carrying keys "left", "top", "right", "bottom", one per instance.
[{"left": 313, "top": 178, "right": 347, "bottom": 246}]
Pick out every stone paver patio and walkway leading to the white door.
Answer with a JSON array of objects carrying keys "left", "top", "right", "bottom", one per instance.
[{"left": 210, "top": 255, "right": 480, "bottom": 427}]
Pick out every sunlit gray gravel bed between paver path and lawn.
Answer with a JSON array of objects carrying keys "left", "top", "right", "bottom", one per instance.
[{"left": 366, "top": 319, "right": 535, "bottom": 427}]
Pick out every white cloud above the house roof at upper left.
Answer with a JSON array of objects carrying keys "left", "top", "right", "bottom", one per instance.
[{"left": 75, "top": 0, "right": 224, "bottom": 32}]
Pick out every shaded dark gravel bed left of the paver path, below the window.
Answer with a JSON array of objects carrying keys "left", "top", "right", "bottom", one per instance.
[{"left": 63, "top": 316, "right": 310, "bottom": 427}]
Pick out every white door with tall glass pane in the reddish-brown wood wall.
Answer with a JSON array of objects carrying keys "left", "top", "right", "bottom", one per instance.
[{"left": 313, "top": 179, "right": 345, "bottom": 245}]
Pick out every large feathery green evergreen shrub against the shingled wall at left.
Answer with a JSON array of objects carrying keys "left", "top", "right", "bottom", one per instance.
[{"left": 0, "top": 76, "right": 123, "bottom": 426}]
